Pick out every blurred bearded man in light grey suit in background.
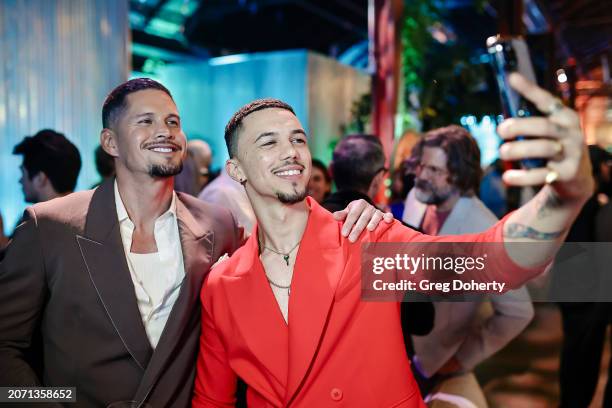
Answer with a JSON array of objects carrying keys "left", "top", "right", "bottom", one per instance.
[{"left": 404, "top": 125, "right": 534, "bottom": 407}]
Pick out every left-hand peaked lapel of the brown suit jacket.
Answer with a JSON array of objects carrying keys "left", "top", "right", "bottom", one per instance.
[{"left": 77, "top": 180, "right": 153, "bottom": 371}]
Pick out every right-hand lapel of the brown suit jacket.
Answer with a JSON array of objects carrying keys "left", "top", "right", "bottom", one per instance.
[{"left": 135, "top": 194, "right": 214, "bottom": 401}]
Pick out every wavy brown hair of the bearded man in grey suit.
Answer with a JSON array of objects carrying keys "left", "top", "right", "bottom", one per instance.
[{"left": 411, "top": 125, "right": 482, "bottom": 194}]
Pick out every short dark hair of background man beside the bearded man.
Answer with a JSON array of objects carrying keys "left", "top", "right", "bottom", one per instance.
[{"left": 331, "top": 134, "right": 385, "bottom": 191}]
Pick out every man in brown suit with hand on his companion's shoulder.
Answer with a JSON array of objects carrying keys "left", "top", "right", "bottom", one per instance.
[{"left": 0, "top": 78, "right": 390, "bottom": 408}]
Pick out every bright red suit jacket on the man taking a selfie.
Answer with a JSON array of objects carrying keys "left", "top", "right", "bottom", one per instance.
[{"left": 193, "top": 198, "right": 537, "bottom": 408}]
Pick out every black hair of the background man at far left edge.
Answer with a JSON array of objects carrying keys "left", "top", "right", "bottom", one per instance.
[{"left": 13, "top": 129, "right": 81, "bottom": 194}]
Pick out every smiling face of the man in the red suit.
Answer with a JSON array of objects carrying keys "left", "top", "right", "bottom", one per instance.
[{"left": 228, "top": 108, "right": 311, "bottom": 204}]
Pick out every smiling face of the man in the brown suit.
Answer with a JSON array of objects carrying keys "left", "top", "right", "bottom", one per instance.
[{"left": 102, "top": 89, "right": 186, "bottom": 178}]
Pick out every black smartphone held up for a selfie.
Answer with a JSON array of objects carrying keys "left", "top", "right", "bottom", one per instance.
[{"left": 487, "top": 35, "right": 547, "bottom": 169}]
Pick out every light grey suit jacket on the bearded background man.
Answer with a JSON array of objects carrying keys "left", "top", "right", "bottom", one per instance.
[{"left": 403, "top": 193, "right": 534, "bottom": 376}]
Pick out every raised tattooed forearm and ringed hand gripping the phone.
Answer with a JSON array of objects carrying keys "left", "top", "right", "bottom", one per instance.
[{"left": 498, "top": 74, "right": 594, "bottom": 267}]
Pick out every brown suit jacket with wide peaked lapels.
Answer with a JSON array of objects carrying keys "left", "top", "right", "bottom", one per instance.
[{"left": 0, "top": 181, "right": 239, "bottom": 408}]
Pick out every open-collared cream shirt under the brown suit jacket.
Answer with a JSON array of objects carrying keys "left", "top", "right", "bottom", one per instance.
[{"left": 115, "top": 181, "right": 185, "bottom": 348}]
